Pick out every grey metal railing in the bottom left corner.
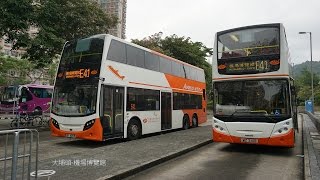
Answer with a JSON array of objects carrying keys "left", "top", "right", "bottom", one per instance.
[{"left": 0, "top": 129, "right": 39, "bottom": 180}]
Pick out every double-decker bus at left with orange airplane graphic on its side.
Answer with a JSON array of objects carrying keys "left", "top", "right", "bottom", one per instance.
[{"left": 50, "top": 34, "right": 206, "bottom": 141}]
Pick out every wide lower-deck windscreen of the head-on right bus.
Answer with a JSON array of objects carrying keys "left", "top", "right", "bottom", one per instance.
[{"left": 214, "top": 80, "right": 290, "bottom": 116}]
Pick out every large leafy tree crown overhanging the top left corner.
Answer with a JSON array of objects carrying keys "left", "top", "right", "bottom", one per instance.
[{"left": 0, "top": 0, "right": 117, "bottom": 67}]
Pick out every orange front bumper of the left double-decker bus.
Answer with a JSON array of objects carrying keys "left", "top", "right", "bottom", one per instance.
[{"left": 50, "top": 118, "right": 103, "bottom": 141}]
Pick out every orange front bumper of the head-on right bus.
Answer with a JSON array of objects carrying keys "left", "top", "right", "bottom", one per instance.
[{"left": 212, "top": 128, "right": 295, "bottom": 147}]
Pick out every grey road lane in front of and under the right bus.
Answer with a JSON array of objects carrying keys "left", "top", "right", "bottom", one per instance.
[{"left": 127, "top": 121, "right": 303, "bottom": 180}]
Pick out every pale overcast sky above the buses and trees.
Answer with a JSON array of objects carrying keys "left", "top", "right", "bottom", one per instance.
[{"left": 126, "top": 0, "right": 320, "bottom": 64}]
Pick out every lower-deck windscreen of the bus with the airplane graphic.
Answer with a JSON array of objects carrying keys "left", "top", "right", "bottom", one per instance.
[{"left": 52, "top": 85, "right": 98, "bottom": 116}]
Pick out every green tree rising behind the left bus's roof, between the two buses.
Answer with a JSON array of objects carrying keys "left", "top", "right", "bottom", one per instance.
[{"left": 132, "top": 32, "right": 212, "bottom": 95}]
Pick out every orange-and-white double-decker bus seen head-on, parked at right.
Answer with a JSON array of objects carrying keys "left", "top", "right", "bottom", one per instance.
[{"left": 212, "top": 23, "right": 297, "bottom": 147}]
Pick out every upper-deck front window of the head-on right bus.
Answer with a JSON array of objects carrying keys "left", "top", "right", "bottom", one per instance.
[{"left": 218, "top": 28, "right": 280, "bottom": 59}]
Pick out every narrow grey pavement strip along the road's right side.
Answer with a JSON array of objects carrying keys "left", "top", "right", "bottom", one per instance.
[{"left": 302, "top": 114, "right": 320, "bottom": 180}]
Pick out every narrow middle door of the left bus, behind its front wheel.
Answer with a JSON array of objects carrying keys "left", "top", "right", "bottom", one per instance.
[{"left": 161, "top": 92, "right": 172, "bottom": 130}]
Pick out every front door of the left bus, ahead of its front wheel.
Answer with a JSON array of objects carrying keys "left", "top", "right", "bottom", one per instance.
[{"left": 101, "top": 85, "right": 124, "bottom": 138}]
